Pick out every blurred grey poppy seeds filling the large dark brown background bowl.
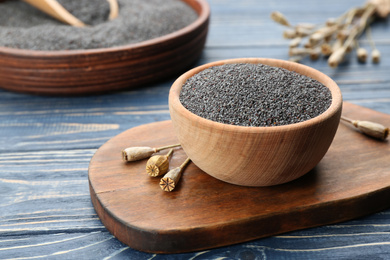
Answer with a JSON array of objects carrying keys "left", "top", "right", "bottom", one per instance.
[{"left": 0, "top": 0, "right": 198, "bottom": 50}]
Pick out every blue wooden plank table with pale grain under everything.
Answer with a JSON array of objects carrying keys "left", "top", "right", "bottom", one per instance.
[{"left": 0, "top": 0, "right": 390, "bottom": 259}]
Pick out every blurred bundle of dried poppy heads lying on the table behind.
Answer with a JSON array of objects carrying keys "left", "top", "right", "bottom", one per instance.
[{"left": 271, "top": 0, "right": 390, "bottom": 68}]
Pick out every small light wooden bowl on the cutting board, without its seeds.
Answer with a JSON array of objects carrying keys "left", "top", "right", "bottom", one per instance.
[{"left": 169, "top": 58, "right": 342, "bottom": 186}]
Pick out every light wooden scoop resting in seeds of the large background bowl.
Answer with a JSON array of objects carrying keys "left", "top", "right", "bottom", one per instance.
[{"left": 23, "top": 0, "right": 118, "bottom": 27}]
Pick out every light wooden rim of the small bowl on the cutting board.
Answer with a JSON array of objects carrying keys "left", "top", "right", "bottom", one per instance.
[{"left": 169, "top": 58, "right": 343, "bottom": 133}]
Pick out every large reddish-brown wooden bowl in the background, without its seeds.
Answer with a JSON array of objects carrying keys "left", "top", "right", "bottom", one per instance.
[{"left": 0, "top": 0, "right": 210, "bottom": 95}]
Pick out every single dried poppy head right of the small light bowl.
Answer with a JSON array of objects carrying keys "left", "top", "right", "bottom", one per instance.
[{"left": 341, "top": 116, "right": 389, "bottom": 140}]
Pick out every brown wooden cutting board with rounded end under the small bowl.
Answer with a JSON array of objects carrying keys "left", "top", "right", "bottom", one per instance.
[{"left": 89, "top": 103, "right": 390, "bottom": 253}]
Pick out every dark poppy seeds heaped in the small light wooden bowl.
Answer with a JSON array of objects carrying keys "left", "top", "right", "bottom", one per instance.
[{"left": 179, "top": 63, "right": 332, "bottom": 126}]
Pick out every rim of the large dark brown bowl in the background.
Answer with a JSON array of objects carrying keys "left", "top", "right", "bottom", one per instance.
[{"left": 0, "top": 0, "right": 210, "bottom": 57}]
